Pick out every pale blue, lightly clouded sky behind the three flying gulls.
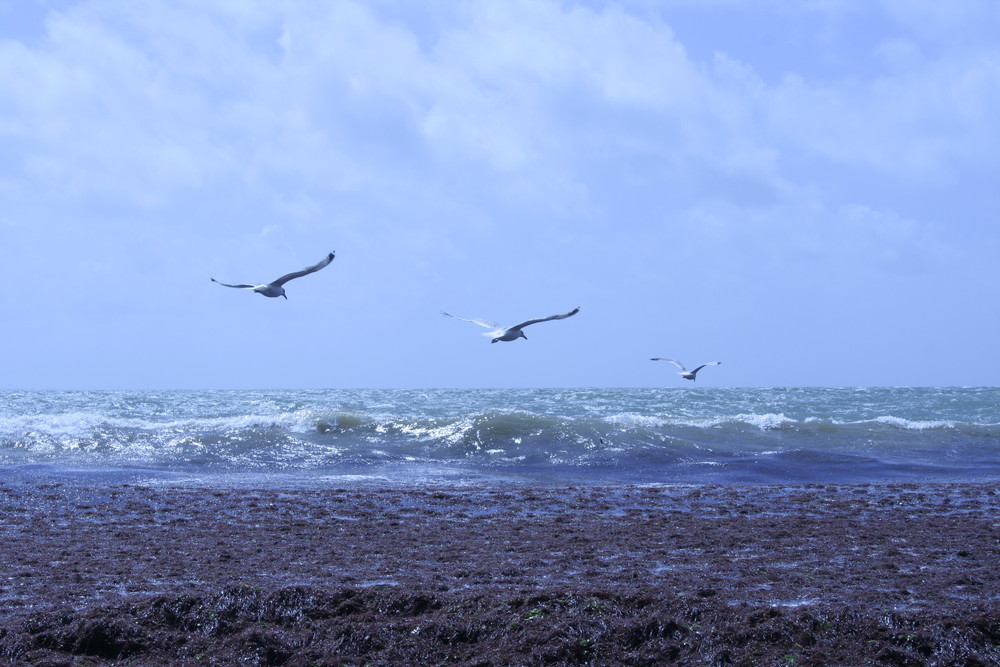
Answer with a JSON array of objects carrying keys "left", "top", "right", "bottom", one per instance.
[{"left": 0, "top": 0, "right": 1000, "bottom": 390}]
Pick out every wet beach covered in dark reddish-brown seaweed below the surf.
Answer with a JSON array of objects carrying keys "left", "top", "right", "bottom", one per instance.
[{"left": 0, "top": 480, "right": 1000, "bottom": 666}]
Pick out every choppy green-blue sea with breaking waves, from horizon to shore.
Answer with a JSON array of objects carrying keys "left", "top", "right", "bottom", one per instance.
[{"left": 0, "top": 387, "right": 1000, "bottom": 485}]
